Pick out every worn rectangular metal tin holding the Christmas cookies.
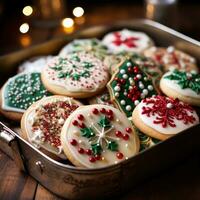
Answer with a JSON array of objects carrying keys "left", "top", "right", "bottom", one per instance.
[{"left": 0, "top": 20, "right": 200, "bottom": 199}]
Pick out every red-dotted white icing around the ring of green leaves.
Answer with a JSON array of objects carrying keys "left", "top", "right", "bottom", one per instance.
[{"left": 42, "top": 52, "right": 109, "bottom": 92}]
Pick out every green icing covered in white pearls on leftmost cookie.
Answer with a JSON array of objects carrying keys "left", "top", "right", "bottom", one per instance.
[{"left": 3, "top": 72, "right": 51, "bottom": 110}]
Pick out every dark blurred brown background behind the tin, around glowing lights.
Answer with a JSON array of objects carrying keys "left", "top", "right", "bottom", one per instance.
[{"left": 0, "top": 0, "right": 200, "bottom": 55}]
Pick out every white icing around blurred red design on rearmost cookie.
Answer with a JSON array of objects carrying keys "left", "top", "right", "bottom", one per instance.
[{"left": 102, "top": 29, "right": 153, "bottom": 53}]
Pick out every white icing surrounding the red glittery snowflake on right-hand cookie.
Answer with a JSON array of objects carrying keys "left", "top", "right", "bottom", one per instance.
[{"left": 137, "top": 98, "right": 199, "bottom": 135}]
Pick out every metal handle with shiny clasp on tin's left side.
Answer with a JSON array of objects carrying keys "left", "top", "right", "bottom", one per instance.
[{"left": 0, "top": 123, "right": 26, "bottom": 171}]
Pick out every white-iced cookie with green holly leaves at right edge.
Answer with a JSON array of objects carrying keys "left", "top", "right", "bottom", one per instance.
[{"left": 160, "top": 70, "right": 200, "bottom": 106}]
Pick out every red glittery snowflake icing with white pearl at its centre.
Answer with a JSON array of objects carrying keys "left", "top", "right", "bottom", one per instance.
[{"left": 142, "top": 95, "right": 196, "bottom": 127}]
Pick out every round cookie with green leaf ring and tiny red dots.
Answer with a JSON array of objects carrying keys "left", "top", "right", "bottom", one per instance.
[{"left": 42, "top": 52, "right": 109, "bottom": 98}]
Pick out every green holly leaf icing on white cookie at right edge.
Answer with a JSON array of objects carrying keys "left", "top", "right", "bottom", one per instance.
[{"left": 164, "top": 69, "right": 200, "bottom": 94}]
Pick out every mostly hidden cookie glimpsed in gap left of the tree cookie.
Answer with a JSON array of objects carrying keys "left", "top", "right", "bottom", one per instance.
[{"left": 88, "top": 89, "right": 114, "bottom": 106}]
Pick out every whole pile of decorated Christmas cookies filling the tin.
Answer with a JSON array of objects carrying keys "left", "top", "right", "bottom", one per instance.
[{"left": 0, "top": 29, "right": 200, "bottom": 168}]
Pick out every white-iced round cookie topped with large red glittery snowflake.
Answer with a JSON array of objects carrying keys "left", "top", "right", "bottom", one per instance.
[{"left": 133, "top": 96, "right": 199, "bottom": 140}]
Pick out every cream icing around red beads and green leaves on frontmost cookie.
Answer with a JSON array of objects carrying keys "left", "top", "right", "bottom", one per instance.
[{"left": 61, "top": 105, "right": 138, "bottom": 168}]
